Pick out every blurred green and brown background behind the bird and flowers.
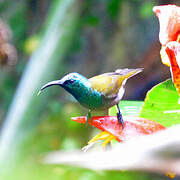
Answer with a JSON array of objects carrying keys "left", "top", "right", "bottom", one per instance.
[{"left": 0, "top": 0, "right": 180, "bottom": 180}]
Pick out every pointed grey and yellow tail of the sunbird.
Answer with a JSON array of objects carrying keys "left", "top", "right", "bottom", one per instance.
[{"left": 115, "top": 68, "right": 144, "bottom": 79}]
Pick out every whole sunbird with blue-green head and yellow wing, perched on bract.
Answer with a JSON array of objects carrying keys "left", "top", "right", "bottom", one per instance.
[{"left": 38, "top": 68, "right": 143, "bottom": 127}]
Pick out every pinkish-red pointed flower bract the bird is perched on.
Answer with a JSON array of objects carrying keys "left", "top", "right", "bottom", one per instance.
[{"left": 72, "top": 116, "right": 166, "bottom": 142}]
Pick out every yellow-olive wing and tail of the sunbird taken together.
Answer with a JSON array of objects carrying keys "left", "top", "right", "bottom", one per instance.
[{"left": 89, "top": 68, "right": 143, "bottom": 98}]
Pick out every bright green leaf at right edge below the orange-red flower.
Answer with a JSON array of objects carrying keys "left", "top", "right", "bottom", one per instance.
[{"left": 140, "top": 80, "right": 180, "bottom": 127}]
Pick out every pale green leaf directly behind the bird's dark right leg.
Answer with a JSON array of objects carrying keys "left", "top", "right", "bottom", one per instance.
[{"left": 110, "top": 101, "right": 143, "bottom": 116}]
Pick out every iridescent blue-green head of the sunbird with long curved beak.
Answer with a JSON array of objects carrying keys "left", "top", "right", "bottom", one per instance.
[{"left": 38, "top": 72, "right": 90, "bottom": 97}]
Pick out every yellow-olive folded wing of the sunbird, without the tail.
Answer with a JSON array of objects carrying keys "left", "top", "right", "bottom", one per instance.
[{"left": 89, "top": 73, "right": 123, "bottom": 98}]
